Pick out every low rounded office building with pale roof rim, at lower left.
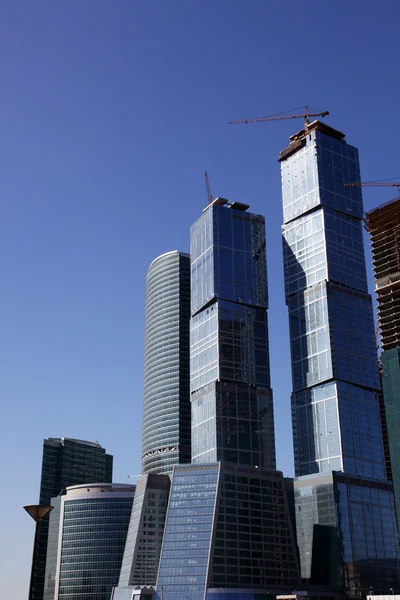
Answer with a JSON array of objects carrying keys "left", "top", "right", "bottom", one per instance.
[{"left": 50, "top": 483, "right": 135, "bottom": 600}]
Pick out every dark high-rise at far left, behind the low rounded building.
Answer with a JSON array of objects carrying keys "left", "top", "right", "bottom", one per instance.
[{"left": 29, "top": 438, "right": 113, "bottom": 600}]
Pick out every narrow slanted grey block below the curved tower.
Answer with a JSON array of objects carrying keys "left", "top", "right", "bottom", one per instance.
[{"left": 118, "top": 473, "right": 171, "bottom": 587}]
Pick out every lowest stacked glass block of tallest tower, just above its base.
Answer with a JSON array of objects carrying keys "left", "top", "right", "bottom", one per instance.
[{"left": 292, "top": 381, "right": 386, "bottom": 479}]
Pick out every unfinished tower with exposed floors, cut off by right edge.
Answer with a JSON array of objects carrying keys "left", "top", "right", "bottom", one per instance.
[{"left": 366, "top": 198, "right": 400, "bottom": 517}]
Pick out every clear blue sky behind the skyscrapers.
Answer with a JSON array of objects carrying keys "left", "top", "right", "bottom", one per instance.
[{"left": 0, "top": 0, "right": 400, "bottom": 600}]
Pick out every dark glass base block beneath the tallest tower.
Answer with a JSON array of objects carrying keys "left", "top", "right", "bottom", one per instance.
[{"left": 294, "top": 473, "right": 400, "bottom": 598}]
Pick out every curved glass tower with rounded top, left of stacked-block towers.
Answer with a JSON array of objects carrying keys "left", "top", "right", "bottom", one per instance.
[{"left": 142, "top": 250, "right": 191, "bottom": 474}]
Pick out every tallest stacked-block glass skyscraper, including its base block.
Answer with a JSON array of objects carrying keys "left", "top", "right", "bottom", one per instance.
[{"left": 279, "top": 121, "right": 399, "bottom": 597}]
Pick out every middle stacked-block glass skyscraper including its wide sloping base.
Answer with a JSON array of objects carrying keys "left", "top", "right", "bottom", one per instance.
[{"left": 157, "top": 198, "right": 299, "bottom": 600}]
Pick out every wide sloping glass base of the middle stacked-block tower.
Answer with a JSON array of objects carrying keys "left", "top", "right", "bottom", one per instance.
[{"left": 157, "top": 462, "right": 299, "bottom": 600}]
